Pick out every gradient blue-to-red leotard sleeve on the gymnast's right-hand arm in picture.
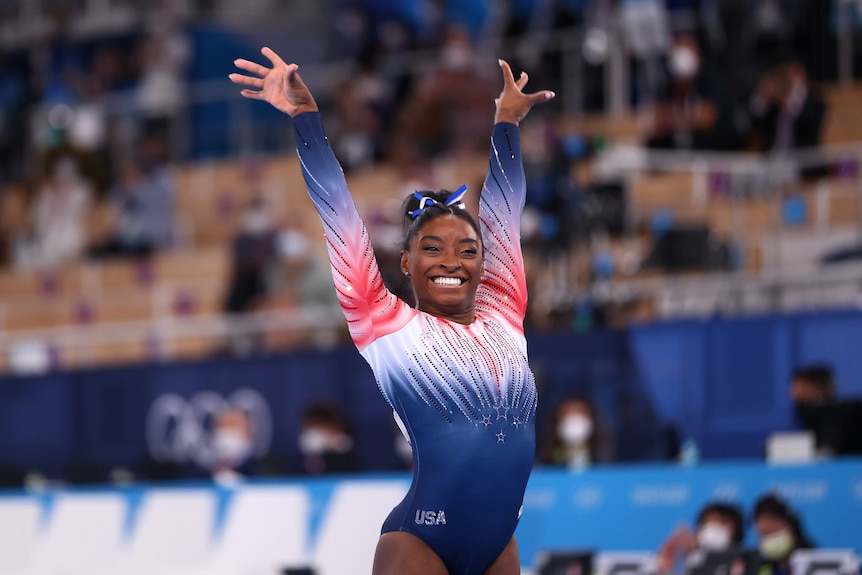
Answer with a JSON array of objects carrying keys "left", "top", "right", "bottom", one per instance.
[{"left": 476, "top": 122, "right": 527, "bottom": 333}]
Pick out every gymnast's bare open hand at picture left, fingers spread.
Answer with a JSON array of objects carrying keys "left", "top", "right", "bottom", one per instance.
[{"left": 228, "top": 47, "right": 317, "bottom": 118}]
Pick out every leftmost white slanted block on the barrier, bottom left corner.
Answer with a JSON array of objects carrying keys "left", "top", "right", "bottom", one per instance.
[{"left": 0, "top": 497, "right": 41, "bottom": 575}]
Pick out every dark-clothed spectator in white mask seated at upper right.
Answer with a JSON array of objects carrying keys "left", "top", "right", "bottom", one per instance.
[{"left": 647, "top": 34, "right": 742, "bottom": 150}]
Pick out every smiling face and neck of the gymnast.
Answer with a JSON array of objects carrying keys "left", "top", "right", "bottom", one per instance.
[{"left": 401, "top": 215, "right": 482, "bottom": 324}]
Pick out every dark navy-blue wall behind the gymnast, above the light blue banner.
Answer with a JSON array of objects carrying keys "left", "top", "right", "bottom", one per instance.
[{"left": 0, "top": 311, "right": 862, "bottom": 475}]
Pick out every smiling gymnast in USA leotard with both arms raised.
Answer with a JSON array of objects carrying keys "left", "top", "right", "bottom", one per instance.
[{"left": 231, "top": 48, "right": 553, "bottom": 575}]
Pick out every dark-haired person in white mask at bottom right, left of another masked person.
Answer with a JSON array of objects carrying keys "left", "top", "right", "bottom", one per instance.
[{"left": 656, "top": 501, "right": 745, "bottom": 575}]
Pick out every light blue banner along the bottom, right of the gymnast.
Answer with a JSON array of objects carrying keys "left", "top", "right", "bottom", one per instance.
[{"left": 517, "top": 459, "right": 862, "bottom": 558}]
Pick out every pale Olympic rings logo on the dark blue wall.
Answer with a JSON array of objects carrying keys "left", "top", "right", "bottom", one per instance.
[{"left": 146, "top": 388, "right": 272, "bottom": 467}]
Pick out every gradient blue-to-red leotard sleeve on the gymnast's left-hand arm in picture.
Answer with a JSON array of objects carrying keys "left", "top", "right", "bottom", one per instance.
[{"left": 293, "top": 112, "right": 412, "bottom": 351}]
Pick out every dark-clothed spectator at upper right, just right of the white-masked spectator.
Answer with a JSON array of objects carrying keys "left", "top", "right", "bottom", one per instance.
[{"left": 749, "top": 60, "right": 826, "bottom": 152}]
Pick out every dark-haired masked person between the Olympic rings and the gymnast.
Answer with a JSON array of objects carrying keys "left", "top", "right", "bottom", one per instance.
[{"left": 299, "top": 402, "right": 361, "bottom": 475}]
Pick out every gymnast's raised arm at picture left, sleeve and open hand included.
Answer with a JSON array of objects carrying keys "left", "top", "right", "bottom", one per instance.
[{"left": 230, "top": 48, "right": 411, "bottom": 351}]
